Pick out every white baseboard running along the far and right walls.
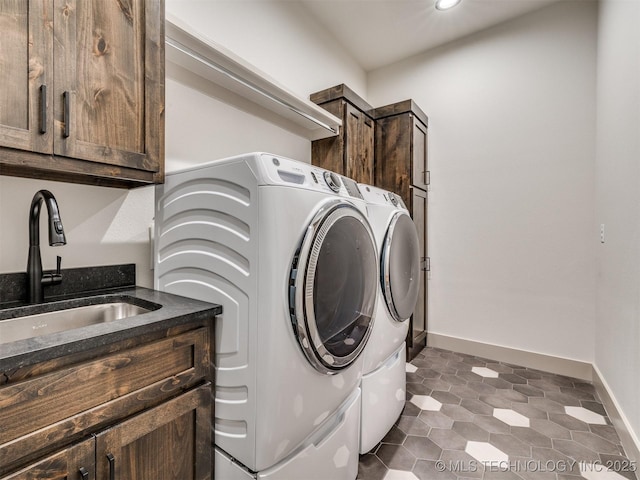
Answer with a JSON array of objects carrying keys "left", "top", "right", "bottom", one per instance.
[{"left": 427, "top": 332, "right": 640, "bottom": 465}]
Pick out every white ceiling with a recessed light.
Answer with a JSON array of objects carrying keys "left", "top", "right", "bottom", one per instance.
[{"left": 299, "top": 0, "right": 559, "bottom": 71}]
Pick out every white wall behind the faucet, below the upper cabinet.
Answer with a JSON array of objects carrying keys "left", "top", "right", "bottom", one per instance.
[{"left": 0, "top": 176, "right": 153, "bottom": 286}]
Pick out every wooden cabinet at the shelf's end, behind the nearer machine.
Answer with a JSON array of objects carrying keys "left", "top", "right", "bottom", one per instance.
[{"left": 310, "top": 84, "right": 375, "bottom": 185}]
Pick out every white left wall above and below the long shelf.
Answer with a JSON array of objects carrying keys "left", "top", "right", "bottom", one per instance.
[{"left": 166, "top": 0, "right": 366, "bottom": 171}]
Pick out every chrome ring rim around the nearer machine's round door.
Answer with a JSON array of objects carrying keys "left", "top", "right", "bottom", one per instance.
[{"left": 289, "top": 200, "right": 377, "bottom": 375}]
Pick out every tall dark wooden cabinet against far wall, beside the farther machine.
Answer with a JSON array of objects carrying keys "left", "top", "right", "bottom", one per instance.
[{"left": 373, "top": 100, "right": 430, "bottom": 359}]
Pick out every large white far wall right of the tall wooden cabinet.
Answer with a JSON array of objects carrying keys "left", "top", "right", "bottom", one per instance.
[{"left": 368, "top": 1, "right": 597, "bottom": 361}]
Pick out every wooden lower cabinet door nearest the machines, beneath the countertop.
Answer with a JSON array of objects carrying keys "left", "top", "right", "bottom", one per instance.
[{"left": 96, "top": 383, "right": 212, "bottom": 480}]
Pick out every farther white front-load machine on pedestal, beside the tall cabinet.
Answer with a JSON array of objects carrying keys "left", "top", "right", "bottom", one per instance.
[{"left": 358, "top": 184, "right": 420, "bottom": 453}]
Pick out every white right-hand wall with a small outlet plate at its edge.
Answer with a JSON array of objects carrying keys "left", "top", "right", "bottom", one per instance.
[{"left": 595, "top": 0, "right": 640, "bottom": 448}]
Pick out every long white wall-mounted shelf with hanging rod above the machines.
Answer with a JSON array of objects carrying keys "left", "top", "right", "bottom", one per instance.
[{"left": 165, "top": 15, "right": 342, "bottom": 140}]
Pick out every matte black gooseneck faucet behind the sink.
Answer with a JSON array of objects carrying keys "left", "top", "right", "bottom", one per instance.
[{"left": 27, "top": 190, "right": 67, "bottom": 303}]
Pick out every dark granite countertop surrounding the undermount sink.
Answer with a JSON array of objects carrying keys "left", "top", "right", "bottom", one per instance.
[{"left": 0, "top": 287, "right": 222, "bottom": 372}]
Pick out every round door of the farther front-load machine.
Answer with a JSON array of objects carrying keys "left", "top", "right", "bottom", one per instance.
[{"left": 380, "top": 212, "right": 420, "bottom": 322}]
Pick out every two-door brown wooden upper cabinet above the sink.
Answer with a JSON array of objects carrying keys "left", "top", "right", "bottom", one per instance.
[{"left": 0, "top": 0, "right": 164, "bottom": 187}]
